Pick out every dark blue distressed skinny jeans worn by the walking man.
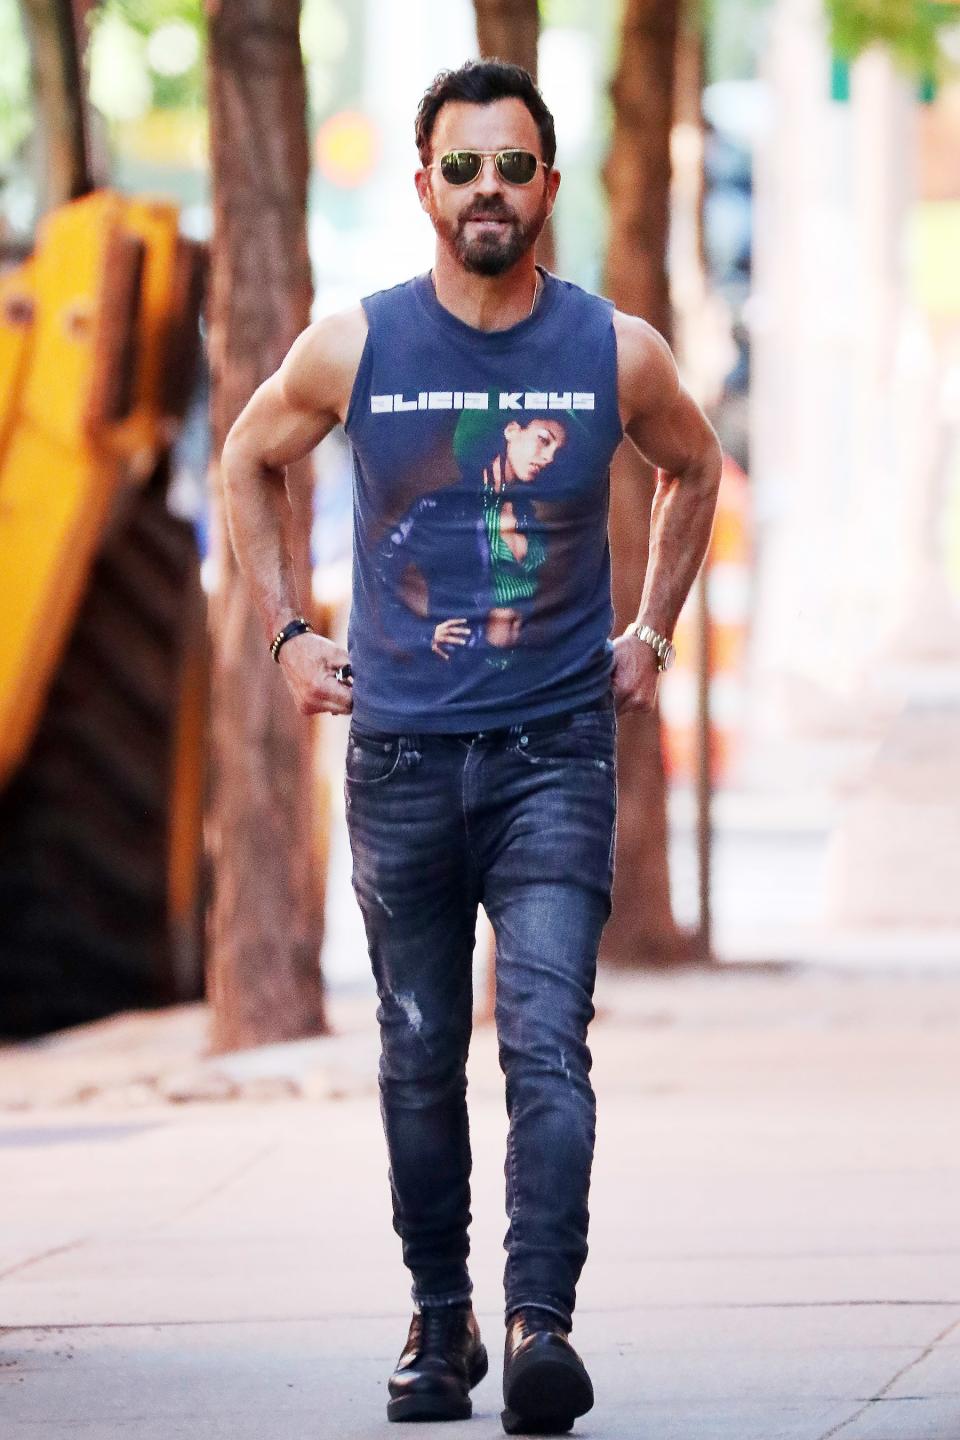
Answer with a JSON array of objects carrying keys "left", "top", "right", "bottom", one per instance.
[{"left": 345, "top": 696, "right": 616, "bottom": 1328}]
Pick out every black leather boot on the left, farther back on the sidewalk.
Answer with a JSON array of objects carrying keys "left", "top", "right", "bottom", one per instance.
[{"left": 387, "top": 1305, "right": 486, "bottom": 1420}]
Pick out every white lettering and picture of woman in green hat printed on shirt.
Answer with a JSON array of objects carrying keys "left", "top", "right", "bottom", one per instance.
[{"left": 371, "top": 392, "right": 593, "bottom": 670}]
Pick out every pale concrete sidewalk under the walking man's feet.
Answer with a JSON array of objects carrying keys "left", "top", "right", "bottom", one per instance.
[{"left": 0, "top": 969, "right": 960, "bottom": 1440}]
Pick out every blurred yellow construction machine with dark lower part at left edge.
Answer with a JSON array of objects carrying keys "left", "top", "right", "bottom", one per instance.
[{"left": 0, "top": 190, "right": 207, "bottom": 1037}]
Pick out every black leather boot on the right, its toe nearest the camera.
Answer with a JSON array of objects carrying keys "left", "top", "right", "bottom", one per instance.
[{"left": 501, "top": 1306, "right": 593, "bottom": 1436}]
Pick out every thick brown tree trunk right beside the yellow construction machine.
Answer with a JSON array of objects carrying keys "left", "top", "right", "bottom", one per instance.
[{"left": 207, "top": 0, "right": 325, "bottom": 1051}]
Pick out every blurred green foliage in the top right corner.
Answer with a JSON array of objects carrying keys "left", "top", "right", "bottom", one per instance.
[{"left": 825, "top": 0, "right": 960, "bottom": 79}]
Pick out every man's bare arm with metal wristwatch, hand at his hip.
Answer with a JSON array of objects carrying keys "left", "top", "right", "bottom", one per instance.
[{"left": 613, "top": 314, "right": 721, "bottom": 710}]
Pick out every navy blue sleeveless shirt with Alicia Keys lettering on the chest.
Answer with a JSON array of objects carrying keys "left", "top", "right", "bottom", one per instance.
[{"left": 345, "top": 271, "right": 623, "bottom": 733}]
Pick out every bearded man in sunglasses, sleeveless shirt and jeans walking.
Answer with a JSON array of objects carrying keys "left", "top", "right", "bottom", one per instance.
[{"left": 223, "top": 60, "right": 720, "bottom": 1433}]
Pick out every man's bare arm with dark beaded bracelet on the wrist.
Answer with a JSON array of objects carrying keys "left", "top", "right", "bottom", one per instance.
[{"left": 220, "top": 310, "right": 366, "bottom": 714}]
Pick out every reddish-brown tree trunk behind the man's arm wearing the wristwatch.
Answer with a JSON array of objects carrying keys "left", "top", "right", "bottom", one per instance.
[{"left": 602, "top": 0, "right": 685, "bottom": 965}]
